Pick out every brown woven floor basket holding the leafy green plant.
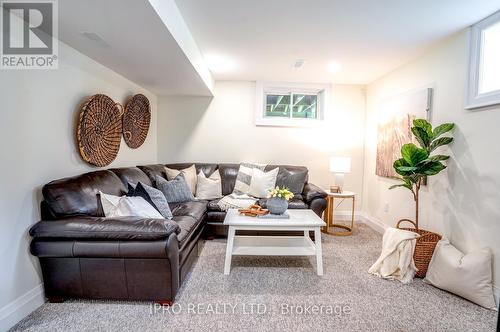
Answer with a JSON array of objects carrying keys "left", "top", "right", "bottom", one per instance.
[{"left": 396, "top": 219, "right": 441, "bottom": 278}]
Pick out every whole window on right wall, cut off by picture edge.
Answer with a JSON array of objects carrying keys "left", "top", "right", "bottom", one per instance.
[{"left": 466, "top": 12, "right": 500, "bottom": 109}]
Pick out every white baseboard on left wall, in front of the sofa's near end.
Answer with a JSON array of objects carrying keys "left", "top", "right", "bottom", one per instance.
[{"left": 0, "top": 284, "right": 45, "bottom": 331}]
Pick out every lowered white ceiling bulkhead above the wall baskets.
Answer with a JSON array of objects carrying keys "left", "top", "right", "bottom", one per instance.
[{"left": 58, "top": 0, "right": 211, "bottom": 95}]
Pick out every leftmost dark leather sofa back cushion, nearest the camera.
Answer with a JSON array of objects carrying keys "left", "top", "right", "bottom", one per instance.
[{"left": 42, "top": 170, "right": 127, "bottom": 218}]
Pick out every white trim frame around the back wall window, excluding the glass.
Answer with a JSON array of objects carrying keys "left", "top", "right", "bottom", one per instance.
[{"left": 255, "top": 82, "right": 331, "bottom": 127}]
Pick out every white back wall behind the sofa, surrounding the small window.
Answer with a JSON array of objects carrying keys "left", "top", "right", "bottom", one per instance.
[{"left": 158, "top": 81, "right": 365, "bottom": 209}]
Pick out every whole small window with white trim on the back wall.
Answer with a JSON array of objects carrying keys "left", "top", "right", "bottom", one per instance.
[{"left": 255, "top": 82, "right": 329, "bottom": 127}]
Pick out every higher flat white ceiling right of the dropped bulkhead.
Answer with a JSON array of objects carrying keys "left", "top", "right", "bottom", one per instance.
[{"left": 176, "top": 0, "right": 500, "bottom": 84}]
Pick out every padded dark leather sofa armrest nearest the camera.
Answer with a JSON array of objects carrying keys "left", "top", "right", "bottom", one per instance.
[{"left": 29, "top": 217, "right": 180, "bottom": 240}]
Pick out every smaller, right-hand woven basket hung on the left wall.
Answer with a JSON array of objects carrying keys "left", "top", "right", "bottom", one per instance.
[{"left": 123, "top": 94, "right": 151, "bottom": 149}]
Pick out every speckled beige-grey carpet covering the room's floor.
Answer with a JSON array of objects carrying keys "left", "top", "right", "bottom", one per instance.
[{"left": 8, "top": 225, "right": 496, "bottom": 331}]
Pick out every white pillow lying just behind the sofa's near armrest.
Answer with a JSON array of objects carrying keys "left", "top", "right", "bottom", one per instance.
[{"left": 99, "top": 192, "right": 165, "bottom": 219}]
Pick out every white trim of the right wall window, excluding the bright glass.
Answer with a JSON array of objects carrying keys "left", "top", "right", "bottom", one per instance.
[{"left": 465, "top": 12, "right": 500, "bottom": 109}]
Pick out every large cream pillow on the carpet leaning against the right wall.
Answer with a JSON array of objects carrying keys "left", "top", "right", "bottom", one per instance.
[{"left": 424, "top": 239, "right": 496, "bottom": 309}]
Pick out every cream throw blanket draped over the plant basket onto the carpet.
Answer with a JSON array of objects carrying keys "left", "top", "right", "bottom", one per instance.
[{"left": 368, "top": 227, "right": 419, "bottom": 284}]
